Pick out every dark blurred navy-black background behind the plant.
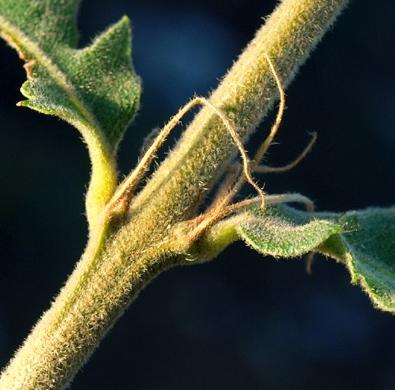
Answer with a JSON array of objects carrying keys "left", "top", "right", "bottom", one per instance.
[{"left": 0, "top": 0, "right": 395, "bottom": 390}]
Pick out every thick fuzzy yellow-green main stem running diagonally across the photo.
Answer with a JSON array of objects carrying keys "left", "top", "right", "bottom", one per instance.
[{"left": 0, "top": 0, "right": 347, "bottom": 390}]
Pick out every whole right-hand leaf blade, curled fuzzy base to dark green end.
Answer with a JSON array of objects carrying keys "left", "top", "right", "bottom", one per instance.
[{"left": 236, "top": 205, "right": 395, "bottom": 313}]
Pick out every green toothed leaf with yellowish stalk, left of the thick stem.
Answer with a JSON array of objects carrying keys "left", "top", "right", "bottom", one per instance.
[{"left": 0, "top": 0, "right": 141, "bottom": 222}]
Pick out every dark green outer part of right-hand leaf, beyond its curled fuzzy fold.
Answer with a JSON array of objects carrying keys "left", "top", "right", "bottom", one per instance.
[{"left": 318, "top": 208, "right": 395, "bottom": 313}]
